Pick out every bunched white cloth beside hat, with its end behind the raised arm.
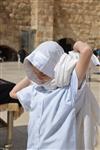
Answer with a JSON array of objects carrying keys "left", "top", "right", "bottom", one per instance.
[{"left": 53, "top": 51, "right": 97, "bottom": 87}]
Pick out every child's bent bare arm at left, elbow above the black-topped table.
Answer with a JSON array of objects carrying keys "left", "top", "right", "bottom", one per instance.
[{"left": 9, "top": 77, "right": 31, "bottom": 99}]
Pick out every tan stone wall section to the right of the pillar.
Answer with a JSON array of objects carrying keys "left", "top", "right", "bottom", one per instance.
[{"left": 54, "top": 0, "right": 100, "bottom": 48}]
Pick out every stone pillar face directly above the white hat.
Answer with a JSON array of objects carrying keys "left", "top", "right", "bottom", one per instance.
[{"left": 36, "top": 0, "right": 54, "bottom": 45}]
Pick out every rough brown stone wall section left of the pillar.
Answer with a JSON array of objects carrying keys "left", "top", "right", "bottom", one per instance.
[{"left": 0, "top": 0, "right": 31, "bottom": 50}]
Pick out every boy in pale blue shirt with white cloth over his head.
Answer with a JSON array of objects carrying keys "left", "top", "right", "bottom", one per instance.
[{"left": 10, "top": 41, "right": 99, "bottom": 150}]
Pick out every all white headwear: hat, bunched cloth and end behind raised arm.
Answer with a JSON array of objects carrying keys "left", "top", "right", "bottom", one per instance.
[{"left": 24, "top": 41, "right": 99, "bottom": 89}]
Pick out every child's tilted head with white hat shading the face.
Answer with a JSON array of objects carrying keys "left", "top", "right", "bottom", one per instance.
[{"left": 24, "top": 41, "right": 64, "bottom": 84}]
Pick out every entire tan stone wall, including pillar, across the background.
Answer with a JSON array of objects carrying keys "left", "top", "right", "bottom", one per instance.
[{"left": 0, "top": 0, "right": 100, "bottom": 50}]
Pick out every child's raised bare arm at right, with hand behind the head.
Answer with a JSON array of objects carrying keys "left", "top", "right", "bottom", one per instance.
[{"left": 73, "top": 41, "right": 92, "bottom": 83}]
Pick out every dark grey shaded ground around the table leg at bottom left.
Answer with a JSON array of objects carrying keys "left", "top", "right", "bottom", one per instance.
[{"left": 0, "top": 126, "right": 27, "bottom": 150}]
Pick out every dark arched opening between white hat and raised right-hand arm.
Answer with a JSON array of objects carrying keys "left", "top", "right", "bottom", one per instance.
[{"left": 57, "top": 38, "right": 75, "bottom": 53}]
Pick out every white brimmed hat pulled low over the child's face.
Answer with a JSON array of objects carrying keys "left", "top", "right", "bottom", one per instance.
[{"left": 24, "top": 41, "right": 64, "bottom": 78}]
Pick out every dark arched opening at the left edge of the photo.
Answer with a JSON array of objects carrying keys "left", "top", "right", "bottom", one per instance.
[{"left": 0, "top": 45, "right": 18, "bottom": 61}]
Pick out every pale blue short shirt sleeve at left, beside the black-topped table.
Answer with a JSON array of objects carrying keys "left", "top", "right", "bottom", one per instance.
[{"left": 17, "top": 85, "right": 34, "bottom": 111}]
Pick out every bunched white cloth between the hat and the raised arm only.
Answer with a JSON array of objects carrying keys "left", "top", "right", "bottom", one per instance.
[{"left": 54, "top": 53, "right": 78, "bottom": 87}]
